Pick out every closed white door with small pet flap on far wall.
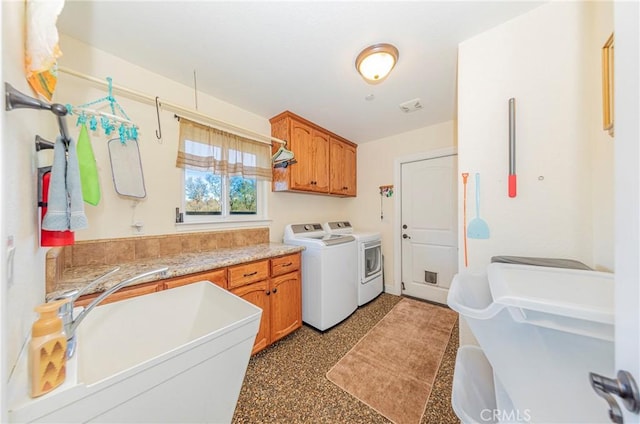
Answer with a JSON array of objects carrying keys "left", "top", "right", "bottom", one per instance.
[{"left": 400, "top": 155, "right": 458, "bottom": 304}]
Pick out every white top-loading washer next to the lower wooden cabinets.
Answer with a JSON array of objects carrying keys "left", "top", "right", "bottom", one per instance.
[{"left": 284, "top": 223, "right": 358, "bottom": 331}]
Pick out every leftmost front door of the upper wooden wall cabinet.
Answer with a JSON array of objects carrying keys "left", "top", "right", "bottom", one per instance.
[{"left": 290, "top": 120, "right": 315, "bottom": 190}]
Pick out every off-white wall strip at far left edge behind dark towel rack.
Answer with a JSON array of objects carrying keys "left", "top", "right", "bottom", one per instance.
[{"left": 0, "top": 2, "right": 57, "bottom": 410}]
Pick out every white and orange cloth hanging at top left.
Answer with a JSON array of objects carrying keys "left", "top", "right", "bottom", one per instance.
[{"left": 25, "top": 0, "right": 64, "bottom": 101}]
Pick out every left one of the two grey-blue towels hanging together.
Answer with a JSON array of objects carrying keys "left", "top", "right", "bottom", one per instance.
[{"left": 42, "top": 137, "right": 69, "bottom": 231}]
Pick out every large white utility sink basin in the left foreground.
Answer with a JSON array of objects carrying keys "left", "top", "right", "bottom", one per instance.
[{"left": 9, "top": 282, "right": 262, "bottom": 423}]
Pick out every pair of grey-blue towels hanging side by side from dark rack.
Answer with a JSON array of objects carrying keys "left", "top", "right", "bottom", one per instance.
[{"left": 42, "top": 136, "right": 88, "bottom": 231}]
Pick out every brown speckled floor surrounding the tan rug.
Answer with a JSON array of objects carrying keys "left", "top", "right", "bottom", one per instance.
[{"left": 233, "top": 293, "right": 460, "bottom": 424}]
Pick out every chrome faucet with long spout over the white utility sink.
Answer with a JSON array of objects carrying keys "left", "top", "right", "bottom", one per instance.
[{"left": 51, "top": 266, "right": 169, "bottom": 358}]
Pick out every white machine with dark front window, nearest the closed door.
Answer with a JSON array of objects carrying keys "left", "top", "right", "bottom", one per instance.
[{"left": 324, "top": 221, "right": 384, "bottom": 306}]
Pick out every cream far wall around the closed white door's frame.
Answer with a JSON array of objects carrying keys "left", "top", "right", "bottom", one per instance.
[{"left": 348, "top": 121, "right": 456, "bottom": 294}]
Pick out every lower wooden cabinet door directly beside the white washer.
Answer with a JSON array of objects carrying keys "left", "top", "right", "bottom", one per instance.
[{"left": 271, "top": 271, "right": 302, "bottom": 343}]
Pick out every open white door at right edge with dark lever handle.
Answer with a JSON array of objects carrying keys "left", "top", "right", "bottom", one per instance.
[{"left": 602, "top": 2, "right": 640, "bottom": 423}]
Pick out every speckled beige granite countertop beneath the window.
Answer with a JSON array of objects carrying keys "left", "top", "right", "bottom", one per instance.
[{"left": 47, "top": 243, "right": 304, "bottom": 300}]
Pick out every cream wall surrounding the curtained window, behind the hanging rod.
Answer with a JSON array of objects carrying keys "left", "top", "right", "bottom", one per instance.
[{"left": 56, "top": 34, "right": 350, "bottom": 242}]
